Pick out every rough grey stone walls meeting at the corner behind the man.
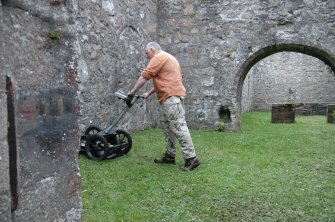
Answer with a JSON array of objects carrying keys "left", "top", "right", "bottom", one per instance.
[{"left": 78, "top": 0, "right": 335, "bottom": 131}]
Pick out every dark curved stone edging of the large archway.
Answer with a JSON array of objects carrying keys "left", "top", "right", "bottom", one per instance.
[{"left": 232, "top": 43, "right": 335, "bottom": 128}]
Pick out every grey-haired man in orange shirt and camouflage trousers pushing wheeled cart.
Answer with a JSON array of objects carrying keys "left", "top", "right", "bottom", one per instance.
[{"left": 128, "top": 42, "right": 200, "bottom": 171}]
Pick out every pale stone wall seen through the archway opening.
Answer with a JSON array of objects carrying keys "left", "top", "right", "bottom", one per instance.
[{"left": 242, "top": 52, "right": 335, "bottom": 111}]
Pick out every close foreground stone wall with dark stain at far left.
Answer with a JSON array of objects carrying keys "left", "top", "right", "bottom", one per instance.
[{"left": 0, "top": 0, "right": 81, "bottom": 221}]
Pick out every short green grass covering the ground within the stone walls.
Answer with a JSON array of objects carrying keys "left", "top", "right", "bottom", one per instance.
[{"left": 79, "top": 112, "right": 335, "bottom": 221}]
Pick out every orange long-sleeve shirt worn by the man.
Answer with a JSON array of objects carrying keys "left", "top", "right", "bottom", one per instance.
[{"left": 142, "top": 51, "right": 186, "bottom": 104}]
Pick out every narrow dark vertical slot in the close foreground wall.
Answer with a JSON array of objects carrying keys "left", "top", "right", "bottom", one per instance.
[{"left": 6, "top": 76, "right": 18, "bottom": 211}]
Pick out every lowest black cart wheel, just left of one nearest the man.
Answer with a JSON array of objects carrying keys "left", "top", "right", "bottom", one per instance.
[{"left": 85, "top": 134, "right": 109, "bottom": 160}]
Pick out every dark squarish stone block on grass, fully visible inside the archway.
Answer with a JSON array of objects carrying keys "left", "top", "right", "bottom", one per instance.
[{"left": 271, "top": 104, "right": 295, "bottom": 123}]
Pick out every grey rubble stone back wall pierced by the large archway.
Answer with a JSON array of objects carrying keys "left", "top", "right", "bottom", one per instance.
[{"left": 158, "top": 0, "right": 335, "bottom": 130}]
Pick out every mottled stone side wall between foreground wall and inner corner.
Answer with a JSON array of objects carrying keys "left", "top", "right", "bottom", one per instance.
[{"left": 77, "top": 0, "right": 161, "bottom": 132}]
